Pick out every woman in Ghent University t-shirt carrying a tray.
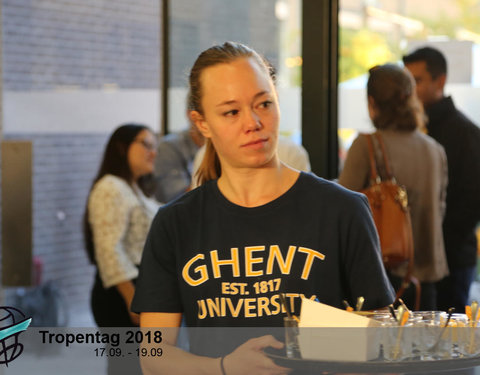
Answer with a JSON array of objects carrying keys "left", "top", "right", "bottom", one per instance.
[{"left": 132, "top": 42, "right": 394, "bottom": 375}]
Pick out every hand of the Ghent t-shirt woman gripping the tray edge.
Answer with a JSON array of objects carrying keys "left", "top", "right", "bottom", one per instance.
[{"left": 223, "top": 335, "right": 291, "bottom": 375}]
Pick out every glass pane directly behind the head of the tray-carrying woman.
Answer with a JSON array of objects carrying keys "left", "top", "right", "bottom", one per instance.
[{"left": 168, "top": 0, "right": 302, "bottom": 142}]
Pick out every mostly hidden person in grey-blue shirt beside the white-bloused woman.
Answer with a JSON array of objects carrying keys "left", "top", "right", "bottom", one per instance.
[{"left": 154, "top": 123, "right": 204, "bottom": 203}]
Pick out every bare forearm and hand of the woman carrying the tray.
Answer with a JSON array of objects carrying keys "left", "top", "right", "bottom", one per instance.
[{"left": 140, "top": 313, "right": 289, "bottom": 375}]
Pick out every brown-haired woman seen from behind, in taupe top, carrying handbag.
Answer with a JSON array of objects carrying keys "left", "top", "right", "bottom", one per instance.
[{"left": 338, "top": 64, "right": 448, "bottom": 310}]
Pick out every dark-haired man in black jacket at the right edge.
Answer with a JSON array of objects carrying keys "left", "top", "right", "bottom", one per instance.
[{"left": 403, "top": 47, "right": 480, "bottom": 312}]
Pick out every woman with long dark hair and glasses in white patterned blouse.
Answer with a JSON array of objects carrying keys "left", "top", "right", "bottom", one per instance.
[{"left": 84, "top": 124, "right": 158, "bottom": 327}]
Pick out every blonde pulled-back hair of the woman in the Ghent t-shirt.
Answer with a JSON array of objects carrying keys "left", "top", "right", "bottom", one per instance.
[{"left": 187, "top": 42, "right": 275, "bottom": 185}]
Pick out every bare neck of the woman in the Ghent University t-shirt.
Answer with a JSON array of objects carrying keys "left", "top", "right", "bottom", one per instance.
[{"left": 218, "top": 162, "right": 299, "bottom": 207}]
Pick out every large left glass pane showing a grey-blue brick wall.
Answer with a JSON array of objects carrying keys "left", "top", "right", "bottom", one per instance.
[{"left": 0, "top": 0, "right": 162, "bottom": 326}]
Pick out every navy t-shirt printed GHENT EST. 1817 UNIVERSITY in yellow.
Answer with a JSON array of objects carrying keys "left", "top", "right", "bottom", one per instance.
[{"left": 132, "top": 173, "right": 394, "bottom": 327}]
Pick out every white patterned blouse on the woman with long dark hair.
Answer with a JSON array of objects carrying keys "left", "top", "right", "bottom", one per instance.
[{"left": 88, "top": 175, "right": 160, "bottom": 288}]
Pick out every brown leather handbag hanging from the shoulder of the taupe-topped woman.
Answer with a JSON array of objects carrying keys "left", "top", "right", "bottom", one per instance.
[{"left": 361, "top": 133, "right": 420, "bottom": 310}]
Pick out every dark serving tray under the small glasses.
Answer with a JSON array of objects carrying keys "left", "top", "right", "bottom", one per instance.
[{"left": 265, "top": 350, "right": 480, "bottom": 374}]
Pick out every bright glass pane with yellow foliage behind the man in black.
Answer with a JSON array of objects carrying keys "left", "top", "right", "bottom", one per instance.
[{"left": 338, "top": 0, "right": 480, "bottom": 167}]
